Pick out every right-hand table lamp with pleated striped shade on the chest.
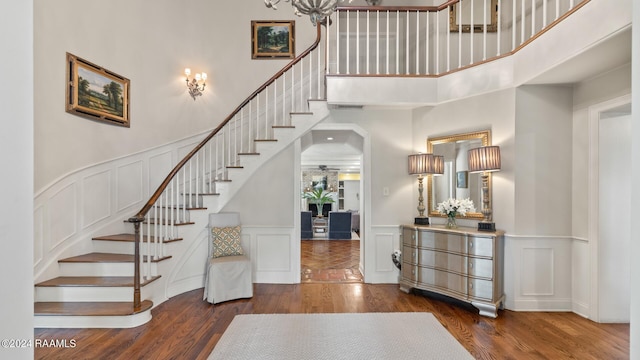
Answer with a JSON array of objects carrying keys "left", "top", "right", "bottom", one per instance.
[{"left": 468, "top": 146, "right": 500, "bottom": 231}]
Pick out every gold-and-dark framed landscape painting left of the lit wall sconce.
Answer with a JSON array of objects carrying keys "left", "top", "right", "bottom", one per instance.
[{"left": 66, "top": 53, "right": 129, "bottom": 127}]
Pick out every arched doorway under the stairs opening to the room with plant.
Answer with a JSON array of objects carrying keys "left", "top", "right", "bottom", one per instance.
[{"left": 300, "top": 124, "right": 365, "bottom": 283}]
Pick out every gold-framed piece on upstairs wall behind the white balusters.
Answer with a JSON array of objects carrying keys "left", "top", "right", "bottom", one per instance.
[{"left": 449, "top": 0, "right": 498, "bottom": 32}]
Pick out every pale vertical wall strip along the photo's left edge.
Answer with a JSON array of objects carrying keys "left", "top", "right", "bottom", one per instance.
[{"left": 0, "top": 0, "right": 34, "bottom": 359}]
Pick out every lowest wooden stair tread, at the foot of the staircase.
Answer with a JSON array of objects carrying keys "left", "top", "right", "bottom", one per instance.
[{"left": 33, "top": 300, "right": 153, "bottom": 316}]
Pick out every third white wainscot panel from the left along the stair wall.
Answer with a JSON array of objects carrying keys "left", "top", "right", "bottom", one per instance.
[{"left": 80, "top": 171, "right": 111, "bottom": 229}]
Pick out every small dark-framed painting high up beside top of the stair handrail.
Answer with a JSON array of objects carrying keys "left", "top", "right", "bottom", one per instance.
[{"left": 251, "top": 20, "right": 295, "bottom": 59}]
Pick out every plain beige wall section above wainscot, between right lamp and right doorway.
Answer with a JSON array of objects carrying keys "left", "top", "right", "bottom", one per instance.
[{"left": 514, "top": 86, "right": 572, "bottom": 236}]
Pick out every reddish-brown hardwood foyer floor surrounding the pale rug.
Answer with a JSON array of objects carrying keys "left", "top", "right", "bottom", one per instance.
[{"left": 35, "top": 283, "right": 629, "bottom": 360}]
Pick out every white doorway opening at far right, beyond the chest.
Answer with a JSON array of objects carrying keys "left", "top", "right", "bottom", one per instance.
[{"left": 589, "top": 96, "right": 631, "bottom": 323}]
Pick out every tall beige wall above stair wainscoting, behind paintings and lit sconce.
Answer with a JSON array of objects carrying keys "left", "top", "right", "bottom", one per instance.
[{"left": 34, "top": 0, "right": 316, "bottom": 191}]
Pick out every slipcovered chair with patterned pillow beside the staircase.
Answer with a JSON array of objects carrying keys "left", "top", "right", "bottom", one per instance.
[{"left": 203, "top": 213, "right": 253, "bottom": 304}]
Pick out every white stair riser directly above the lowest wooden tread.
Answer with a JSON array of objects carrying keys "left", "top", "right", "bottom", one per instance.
[{"left": 35, "top": 284, "right": 152, "bottom": 302}]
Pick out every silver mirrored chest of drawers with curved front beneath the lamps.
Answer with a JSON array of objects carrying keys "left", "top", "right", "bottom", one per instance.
[{"left": 400, "top": 225, "right": 504, "bottom": 318}]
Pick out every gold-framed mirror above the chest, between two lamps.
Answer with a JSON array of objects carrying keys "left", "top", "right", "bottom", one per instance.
[{"left": 427, "top": 130, "right": 491, "bottom": 220}]
